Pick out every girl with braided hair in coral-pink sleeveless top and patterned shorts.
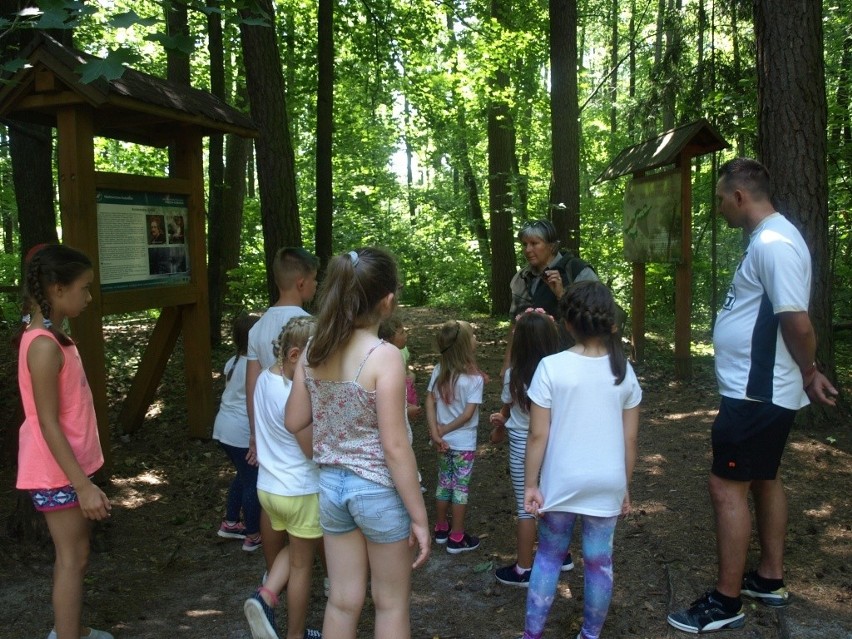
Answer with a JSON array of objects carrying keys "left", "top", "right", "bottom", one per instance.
[{"left": 17, "top": 244, "right": 112, "bottom": 639}]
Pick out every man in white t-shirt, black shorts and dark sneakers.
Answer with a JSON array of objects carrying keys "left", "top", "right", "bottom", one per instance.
[{"left": 668, "top": 158, "right": 837, "bottom": 633}]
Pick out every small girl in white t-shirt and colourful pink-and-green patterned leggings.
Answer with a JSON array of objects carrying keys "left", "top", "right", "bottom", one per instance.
[{"left": 426, "top": 320, "right": 485, "bottom": 555}]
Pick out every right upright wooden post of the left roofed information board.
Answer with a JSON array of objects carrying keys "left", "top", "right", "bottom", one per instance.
[{"left": 175, "top": 132, "right": 215, "bottom": 439}]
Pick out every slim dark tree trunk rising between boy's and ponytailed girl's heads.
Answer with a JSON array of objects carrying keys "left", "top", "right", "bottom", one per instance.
[{"left": 315, "top": 0, "right": 334, "bottom": 272}]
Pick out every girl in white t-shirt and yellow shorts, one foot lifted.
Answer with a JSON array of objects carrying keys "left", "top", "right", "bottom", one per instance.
[{"left": 243, "top": 316, "right": 322, "bottom": 639}]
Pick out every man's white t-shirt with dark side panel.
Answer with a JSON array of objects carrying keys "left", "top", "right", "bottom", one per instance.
[{"left": 713, "top": 213, "right": 811, "bottom": 410}]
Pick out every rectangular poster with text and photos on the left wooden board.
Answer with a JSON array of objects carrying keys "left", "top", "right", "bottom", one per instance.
[{"left": 97, "top": 190, "right": 190, "bottom": 290}]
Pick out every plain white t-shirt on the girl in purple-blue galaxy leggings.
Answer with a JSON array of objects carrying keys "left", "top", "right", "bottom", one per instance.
[{"left": 528, "top": 351, "right": 642, "bottom": 517}]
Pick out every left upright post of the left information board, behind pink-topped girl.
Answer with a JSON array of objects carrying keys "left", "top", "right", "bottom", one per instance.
[{"left": 56, "top": 105, "right": 112, "bottom": 472}]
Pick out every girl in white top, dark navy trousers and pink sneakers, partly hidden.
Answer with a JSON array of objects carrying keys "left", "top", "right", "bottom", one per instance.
[{"left": 213, "top": 313, "right": 260, "bottom": 551}]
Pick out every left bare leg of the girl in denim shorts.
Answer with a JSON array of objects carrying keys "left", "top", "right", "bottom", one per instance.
[{"left": 322, "top": 530, "right": 368, "bottom": 639}]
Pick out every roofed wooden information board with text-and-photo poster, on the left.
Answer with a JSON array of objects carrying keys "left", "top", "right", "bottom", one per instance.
[{"left": 0, "top": 34, "right": 257, "bottom": 468}]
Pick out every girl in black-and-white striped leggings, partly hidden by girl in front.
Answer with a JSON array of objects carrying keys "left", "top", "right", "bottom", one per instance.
[{"left": 490, "top": 307, "right": 574, "bottom": 588}]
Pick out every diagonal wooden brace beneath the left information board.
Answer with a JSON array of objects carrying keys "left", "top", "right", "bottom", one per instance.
[{"left": 118, "top": 306, "right": 182, "bottom": 433}]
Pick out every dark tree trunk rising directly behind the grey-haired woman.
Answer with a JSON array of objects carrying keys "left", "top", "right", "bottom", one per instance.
[{"left": 549, "top": 0, "right": 580, "bottom": 255}]
